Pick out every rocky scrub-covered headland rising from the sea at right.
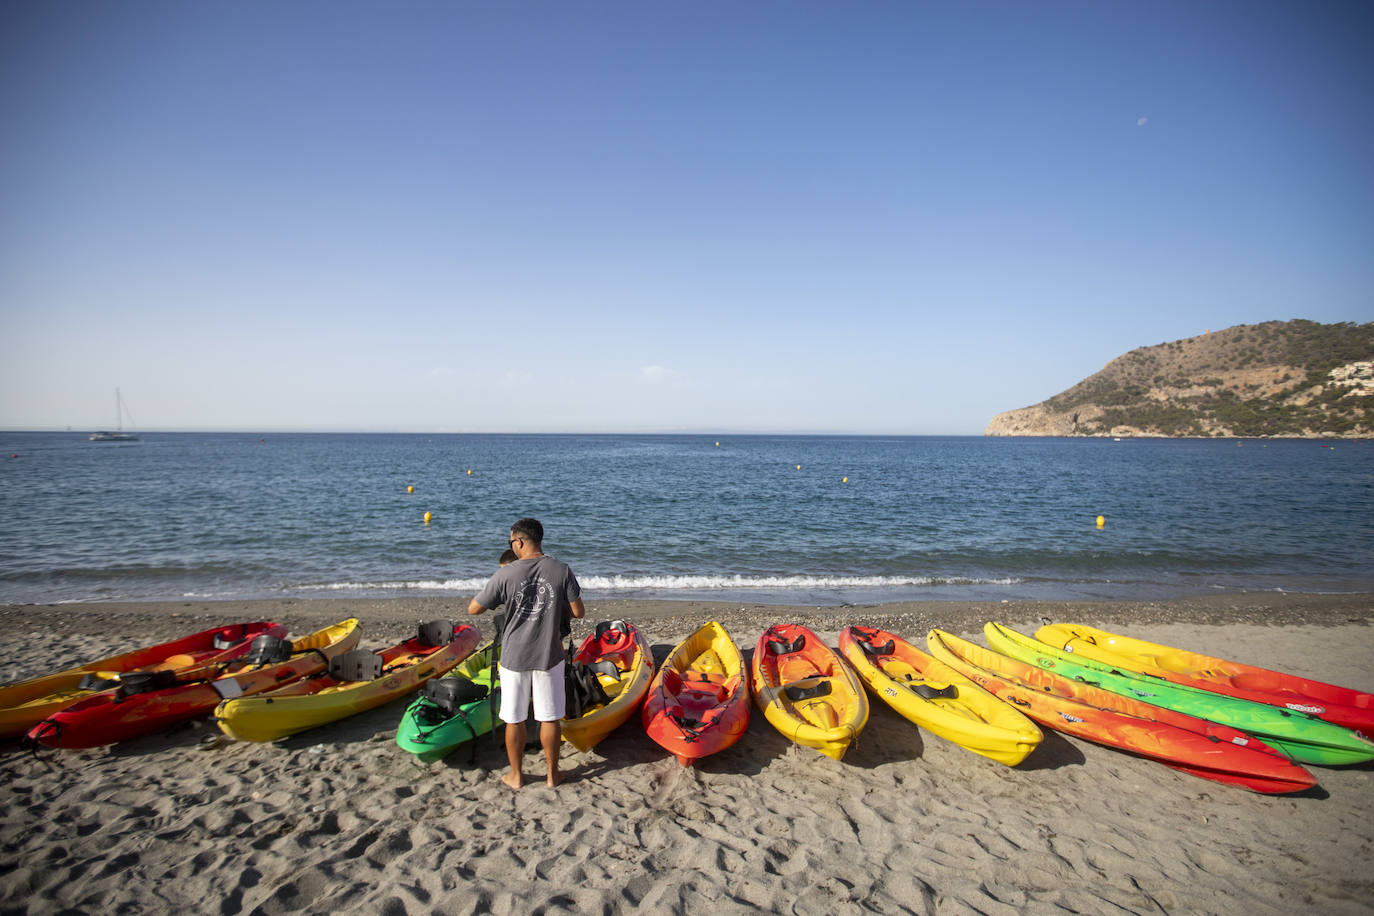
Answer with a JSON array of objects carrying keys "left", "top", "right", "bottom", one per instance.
[{"left": 985, "top": 320, "right": 1374, "bottom": 438}]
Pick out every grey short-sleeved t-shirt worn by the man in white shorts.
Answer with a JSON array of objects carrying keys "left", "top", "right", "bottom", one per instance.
[{"left": 475, "top": 556, "right": 583, "bottom": 672}]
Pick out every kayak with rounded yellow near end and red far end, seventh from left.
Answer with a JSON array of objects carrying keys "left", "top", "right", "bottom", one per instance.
[{"left": 749, "top": 623, "right": 868, "bottom": 759}]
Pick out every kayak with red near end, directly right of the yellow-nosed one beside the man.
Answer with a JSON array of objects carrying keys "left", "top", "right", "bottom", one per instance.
[{"left": 640, "top": 621, "right": 749, "bottom": 766}]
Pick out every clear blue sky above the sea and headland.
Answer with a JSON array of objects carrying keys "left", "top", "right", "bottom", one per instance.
[{"left": 0, "top": 0, "right": 1374, "bottom": 435}]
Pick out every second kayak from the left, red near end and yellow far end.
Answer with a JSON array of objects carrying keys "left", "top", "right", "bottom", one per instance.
[{"left": 29, "top": 618, "right": 361, "bottom": 748}]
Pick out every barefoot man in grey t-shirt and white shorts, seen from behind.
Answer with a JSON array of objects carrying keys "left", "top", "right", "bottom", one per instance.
[{"left": 467, "top": 518, "right": 587, "bottom": 788}]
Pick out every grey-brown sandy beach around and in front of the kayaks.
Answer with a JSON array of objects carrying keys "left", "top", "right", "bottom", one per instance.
[{"left": 0, "top": 593, "right": 1374, "bottom": 916}]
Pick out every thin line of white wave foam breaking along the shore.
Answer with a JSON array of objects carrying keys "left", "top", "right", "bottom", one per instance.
[{"left": 301, "top": 575, "right": 1021, "bottom": 592}]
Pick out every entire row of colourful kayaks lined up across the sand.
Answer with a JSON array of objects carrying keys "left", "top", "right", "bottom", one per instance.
[{"left": 0, "top": 619, "right": 1374, "bottom": 794}]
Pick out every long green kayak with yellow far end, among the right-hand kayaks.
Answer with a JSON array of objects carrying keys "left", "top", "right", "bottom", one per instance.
[{"left": 982, "top": 622, "right": 1374, "bottom": 766}]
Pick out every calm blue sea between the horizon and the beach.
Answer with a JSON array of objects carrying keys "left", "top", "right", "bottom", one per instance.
[{"left": 0, "top": 433, "right": 1374, "bottom": 604}]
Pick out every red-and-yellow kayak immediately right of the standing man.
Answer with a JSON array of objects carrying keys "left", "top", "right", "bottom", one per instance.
[{"left": 563, "top": 621, "right": 654, "bottom": 751}]
